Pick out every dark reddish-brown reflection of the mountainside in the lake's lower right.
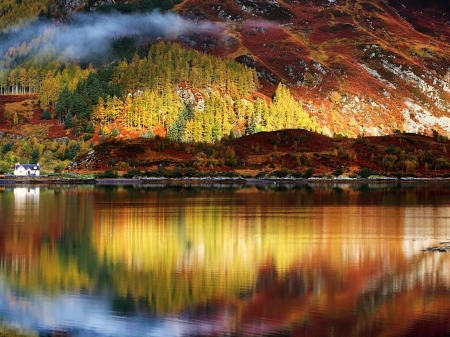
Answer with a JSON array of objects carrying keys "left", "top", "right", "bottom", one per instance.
[{"left": 239, "top": 245, "right": 450, "bottom": 336}]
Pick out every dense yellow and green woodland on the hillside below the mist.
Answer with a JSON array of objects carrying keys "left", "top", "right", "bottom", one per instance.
[{"left": 0, "top": 42, "right": 320, "bottom": 142}]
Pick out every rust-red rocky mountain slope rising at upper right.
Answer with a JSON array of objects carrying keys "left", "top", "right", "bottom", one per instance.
[{"left": 177, "top": 0, "right": 450, "bottom": 136}]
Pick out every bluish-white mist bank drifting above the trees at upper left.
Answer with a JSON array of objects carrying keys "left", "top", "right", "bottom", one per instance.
[{"left": 0, "top": 11, "right": 221, "bottom": 66}]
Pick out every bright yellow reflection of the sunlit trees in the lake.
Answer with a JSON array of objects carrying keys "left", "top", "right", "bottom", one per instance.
[{"left": 93, "top": 197, "right": 255, "bottom": 313}]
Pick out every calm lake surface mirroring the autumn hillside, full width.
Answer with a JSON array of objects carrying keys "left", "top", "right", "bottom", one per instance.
[{"left": 0, "top": 184, "right": 450, "bottom": 336}]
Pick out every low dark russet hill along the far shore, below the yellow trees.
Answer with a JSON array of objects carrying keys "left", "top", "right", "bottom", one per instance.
[{"left": 70, "top": 130, "right": 450, "bottom": 177}]
